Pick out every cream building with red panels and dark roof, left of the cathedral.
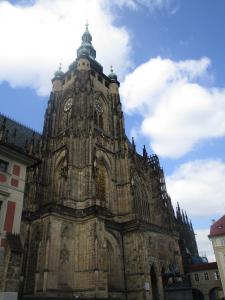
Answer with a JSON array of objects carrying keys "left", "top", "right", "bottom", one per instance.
[{"left": 0, "top": 115, "right": 40, "bottom": 299}]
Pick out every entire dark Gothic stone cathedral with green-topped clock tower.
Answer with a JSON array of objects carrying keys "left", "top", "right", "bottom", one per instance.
[{"left": 22, "top": 27, "right": 192, "bottom": 300}]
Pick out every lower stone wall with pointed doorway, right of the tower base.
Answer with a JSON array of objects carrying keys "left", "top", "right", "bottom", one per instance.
[{"left": 124, "top": 230, "right": 182, "bottom": 300}]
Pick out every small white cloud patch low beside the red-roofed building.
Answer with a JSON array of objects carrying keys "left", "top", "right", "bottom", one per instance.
[{"left": 195, "top": 229, "right": 216, "bottom": 262}]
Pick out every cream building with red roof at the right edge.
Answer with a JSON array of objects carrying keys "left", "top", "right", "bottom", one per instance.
[{"left": 209, "top": 215, "right": 225, "bottom": 295}]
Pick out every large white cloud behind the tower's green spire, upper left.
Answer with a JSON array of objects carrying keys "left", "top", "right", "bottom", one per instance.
[{"left": 0, "top": 0, "right": 130, "bottom": 95}]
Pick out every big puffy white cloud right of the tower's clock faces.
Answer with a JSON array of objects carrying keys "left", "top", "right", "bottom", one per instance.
[{"left": 121, "top": 57, "right": 225, "bottom": 158}]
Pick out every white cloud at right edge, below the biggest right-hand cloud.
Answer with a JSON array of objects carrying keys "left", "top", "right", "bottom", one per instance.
[{"left": 167, "top": 159, "right": 225, "bottom": 220}]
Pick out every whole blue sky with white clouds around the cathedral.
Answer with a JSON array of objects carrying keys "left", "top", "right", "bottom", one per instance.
[{"left": 0, "top": 0, "right": 225, "bottom": 258}]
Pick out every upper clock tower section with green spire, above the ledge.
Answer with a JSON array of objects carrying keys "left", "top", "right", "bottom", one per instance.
[{"left": 40, "top": 25, "right": 129, "bottom": 214}]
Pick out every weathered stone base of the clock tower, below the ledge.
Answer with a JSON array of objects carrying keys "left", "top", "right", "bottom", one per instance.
[{"left": 24, "top": 216, "right": 127, "bottom": 297}]
